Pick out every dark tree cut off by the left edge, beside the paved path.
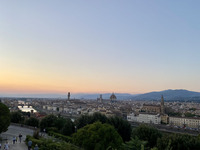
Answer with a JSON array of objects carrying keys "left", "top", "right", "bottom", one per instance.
[{"left": 0, "top": 102, "right": 10, "bottom": 133}]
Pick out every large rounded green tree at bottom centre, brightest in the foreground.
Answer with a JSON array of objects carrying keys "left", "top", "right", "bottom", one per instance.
[{"left": 72, "top": 122, "right": 123, "bottom": 150}]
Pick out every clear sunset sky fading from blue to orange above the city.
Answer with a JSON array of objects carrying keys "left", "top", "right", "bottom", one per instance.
[{"left": 0, "top": 0, "right": 200, "bottom": 94}]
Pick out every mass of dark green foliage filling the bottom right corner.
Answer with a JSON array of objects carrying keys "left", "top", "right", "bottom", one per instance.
[{"left": 122, "top": 125, "right": 200, "bottom": 150}]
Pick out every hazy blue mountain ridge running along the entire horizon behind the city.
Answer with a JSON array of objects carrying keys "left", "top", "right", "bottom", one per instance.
[{"left": 0, "top": 89, "right": 200, "bottom": 101}]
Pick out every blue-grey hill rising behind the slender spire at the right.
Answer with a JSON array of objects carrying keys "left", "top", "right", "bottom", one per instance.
[{"left": 131, "top": 89, "right": 200, "bottom": 101}]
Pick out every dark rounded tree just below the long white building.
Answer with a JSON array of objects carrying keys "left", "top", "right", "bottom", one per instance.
[{"left": 132, "top": 125, "right": 162, "bottom": 148}]
